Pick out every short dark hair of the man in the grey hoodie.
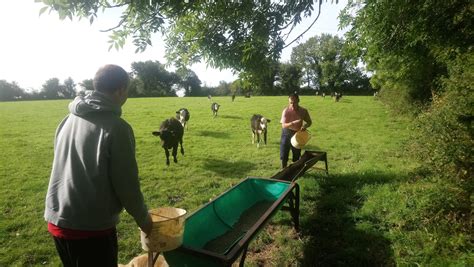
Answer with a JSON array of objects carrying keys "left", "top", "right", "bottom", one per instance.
[{"left": 93, "top": 64, "right": 130, "bottom": 94}]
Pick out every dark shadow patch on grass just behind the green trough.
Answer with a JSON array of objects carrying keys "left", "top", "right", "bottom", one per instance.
[{"left": 203, "top": 158, "right": 255, "bottom": 178}]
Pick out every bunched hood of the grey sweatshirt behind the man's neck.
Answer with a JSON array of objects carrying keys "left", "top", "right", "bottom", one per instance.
[{"left": 69, "top": 91, "right": 122, "bottom": 117}]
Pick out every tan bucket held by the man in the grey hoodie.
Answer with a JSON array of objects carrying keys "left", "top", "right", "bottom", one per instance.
[{"left": 140, "top": 207, "right": 186, "bottom": 252}]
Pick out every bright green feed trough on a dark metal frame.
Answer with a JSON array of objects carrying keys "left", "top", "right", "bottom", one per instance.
[{"left": 163, "top": 177, "right": 299, "bottom": 267}]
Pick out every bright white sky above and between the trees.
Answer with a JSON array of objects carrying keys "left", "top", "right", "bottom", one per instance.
[{"left": 0, "top": 0, "right": 347, "bottom": 90}]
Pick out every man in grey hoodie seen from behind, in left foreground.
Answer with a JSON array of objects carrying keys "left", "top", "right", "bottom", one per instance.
[{"left": 44, "top": 65, "right": 152, "bottom": 267}]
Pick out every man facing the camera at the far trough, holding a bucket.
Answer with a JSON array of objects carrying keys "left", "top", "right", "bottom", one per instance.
[{"left": 280, "top": 92, "right": 312, "bottom": 168}]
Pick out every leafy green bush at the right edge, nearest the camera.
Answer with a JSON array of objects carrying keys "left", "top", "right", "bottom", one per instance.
[{"left": 411, "top": 53, "right": 474, "bottom": 249}]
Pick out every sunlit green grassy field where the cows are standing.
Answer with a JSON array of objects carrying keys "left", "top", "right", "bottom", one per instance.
[{"left": 0, "top": 96, "right": 466, "bottom": 266}]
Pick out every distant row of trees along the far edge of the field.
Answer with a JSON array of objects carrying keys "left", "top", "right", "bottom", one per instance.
[{"left": 0, "top": 34, "right": 372, "bottom": 101}]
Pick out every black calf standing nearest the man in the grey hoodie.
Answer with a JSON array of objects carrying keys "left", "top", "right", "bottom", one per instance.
[{"left": 152, "top": 118, "right": 184, "bottom": 165}]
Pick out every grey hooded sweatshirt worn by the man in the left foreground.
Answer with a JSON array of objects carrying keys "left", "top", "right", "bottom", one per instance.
[{"left": 44, "top": 91, "right": 148, "bottom": 230}]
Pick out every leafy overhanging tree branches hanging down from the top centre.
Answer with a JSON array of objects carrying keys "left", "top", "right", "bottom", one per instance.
[{"left": 41, "top": 0, "right": 337, "bottom": 94}]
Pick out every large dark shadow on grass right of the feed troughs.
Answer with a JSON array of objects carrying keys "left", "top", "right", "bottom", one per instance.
[{"left": 301, "top": 173, "right": 397, "bottom": 266}]
